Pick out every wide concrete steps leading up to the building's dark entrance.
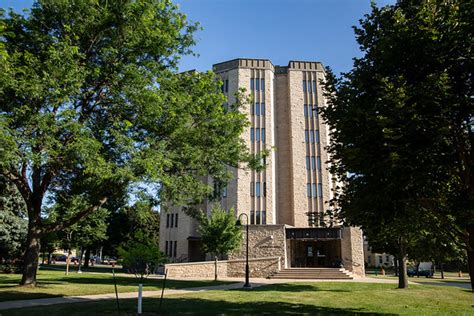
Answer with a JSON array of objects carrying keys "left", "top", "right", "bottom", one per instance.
[{"left": 270, "top": 268, "right": 353, "bottom": 280}]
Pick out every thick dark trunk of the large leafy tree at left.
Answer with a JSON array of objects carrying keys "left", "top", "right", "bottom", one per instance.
[{"left": 20, "top": 227, "right": 41, "bottom": 287}]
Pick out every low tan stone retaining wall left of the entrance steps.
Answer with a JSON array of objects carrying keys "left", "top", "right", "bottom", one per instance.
[{"left": 165, "top": 257, "right": 281, "bottom": 278}]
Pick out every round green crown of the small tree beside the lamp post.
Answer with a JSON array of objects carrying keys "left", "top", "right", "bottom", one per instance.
[{"left": 198, "top": 204, "right": 242, "bottom": 257}]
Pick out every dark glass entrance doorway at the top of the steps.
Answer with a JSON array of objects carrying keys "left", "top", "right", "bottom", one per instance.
[{"left": 290, "top": 239, "right": 341, "bottom": 268}]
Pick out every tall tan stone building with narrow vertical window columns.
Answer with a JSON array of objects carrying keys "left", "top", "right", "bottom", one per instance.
[{"left": 160, "top": 59, "right": 364, "bottom": 274}]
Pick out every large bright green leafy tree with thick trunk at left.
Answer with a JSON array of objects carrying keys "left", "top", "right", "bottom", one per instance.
[{"left": 0, "top": 0, "right": 247, "bottom": 285}]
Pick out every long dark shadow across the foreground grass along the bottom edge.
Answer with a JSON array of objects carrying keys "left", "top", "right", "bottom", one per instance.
[{"left": 3, "top": 298, "right": 395, "bottom": 316}]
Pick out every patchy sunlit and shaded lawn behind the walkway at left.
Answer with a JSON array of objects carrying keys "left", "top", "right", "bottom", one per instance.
[{"left": 0, "top": 266, "right": 229, "bottom": 302}]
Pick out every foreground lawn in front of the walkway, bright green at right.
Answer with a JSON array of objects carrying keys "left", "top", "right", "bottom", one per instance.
[{"left": 2, "top": 282, "right": 474, "bottom": 316}]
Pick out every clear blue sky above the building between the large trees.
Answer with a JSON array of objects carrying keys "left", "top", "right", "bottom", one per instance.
[{"left": 0, "top": 0, "right": 395, "bottom": 73}]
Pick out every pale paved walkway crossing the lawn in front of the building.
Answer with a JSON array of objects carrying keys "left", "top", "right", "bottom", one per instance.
[{"left": 0, "top": 277, "right": 469, "bottom": 310}]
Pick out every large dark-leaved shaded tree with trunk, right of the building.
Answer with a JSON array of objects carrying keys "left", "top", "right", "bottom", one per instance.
[{"left": 322, "top": 0, "right": 474, "bottom": 288}]
